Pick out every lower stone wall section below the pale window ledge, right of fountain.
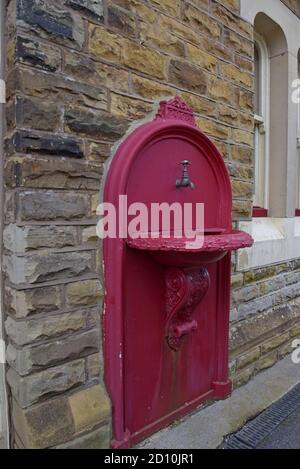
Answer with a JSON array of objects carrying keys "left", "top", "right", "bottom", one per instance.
[{"left": 230, "top": 259, "right": 300, "bottom": 387}]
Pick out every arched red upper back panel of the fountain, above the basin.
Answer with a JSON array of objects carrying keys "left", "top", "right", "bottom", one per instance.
[{"left": 104, "top": 97, "right": 232, "bottom": 232}]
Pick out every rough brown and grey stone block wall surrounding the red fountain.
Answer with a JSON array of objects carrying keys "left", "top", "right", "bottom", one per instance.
[{"left": 4, "top": 0, "right": 297, "bottom": 448}]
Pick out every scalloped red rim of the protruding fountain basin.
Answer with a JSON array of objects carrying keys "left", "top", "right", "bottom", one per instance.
[{"left": 126, "top": 230, "right": 254, "bottom": 253}]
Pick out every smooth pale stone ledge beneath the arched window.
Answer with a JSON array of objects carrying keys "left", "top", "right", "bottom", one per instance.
[{"left": 237, "top": 217, "right": 300, "bottom": 271}]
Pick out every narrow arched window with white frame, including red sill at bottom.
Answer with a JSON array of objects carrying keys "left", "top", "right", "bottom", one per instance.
[{"left": 253, "top": 34, "right": 270, "bottom": 216}]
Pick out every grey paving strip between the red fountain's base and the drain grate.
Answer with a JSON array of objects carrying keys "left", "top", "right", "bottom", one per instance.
[{"left": 138, "top": 356, "right": 300, "bottom": 449}]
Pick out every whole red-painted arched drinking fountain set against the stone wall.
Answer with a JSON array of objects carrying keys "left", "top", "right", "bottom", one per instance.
[{"left": 103, "top": 98, "right": 252, "bottom": 448}]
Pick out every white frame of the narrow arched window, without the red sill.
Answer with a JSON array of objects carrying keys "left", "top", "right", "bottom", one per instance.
[{"left": 254, "top": 33, "right": 270, "bottom": 209}]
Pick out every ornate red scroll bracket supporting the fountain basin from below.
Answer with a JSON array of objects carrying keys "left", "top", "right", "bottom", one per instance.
[{"left": 166, "top": 267, "right": 210, "bottom": 351}]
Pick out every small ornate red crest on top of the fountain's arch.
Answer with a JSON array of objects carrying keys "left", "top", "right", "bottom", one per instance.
[{"left": 155, "top": 96, "right": 196, "bottom": 127}]
